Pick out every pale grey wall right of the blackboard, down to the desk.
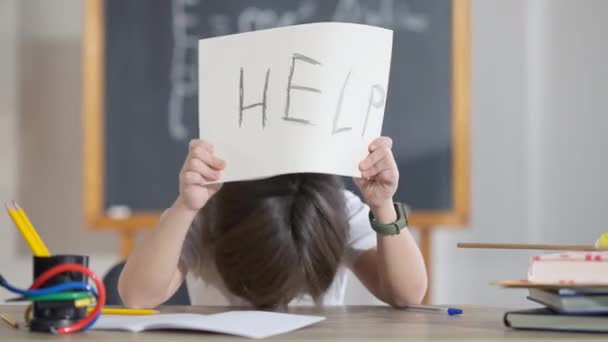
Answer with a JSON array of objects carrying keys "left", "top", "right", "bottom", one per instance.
[{"left": 435, "top": 0, "right": 608, "bottom": 305}]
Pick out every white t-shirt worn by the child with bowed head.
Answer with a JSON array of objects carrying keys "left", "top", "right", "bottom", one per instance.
[{"left": 181, "top": 190, "right": 376, "bottom": 306}]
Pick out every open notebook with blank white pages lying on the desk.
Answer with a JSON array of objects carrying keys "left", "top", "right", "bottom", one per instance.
[{"left": 92, "top": 311, "right": 325, "bottom": 339}]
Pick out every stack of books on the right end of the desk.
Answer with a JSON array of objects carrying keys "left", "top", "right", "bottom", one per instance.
[{"left": 501, "top": 252, "right": 608, "bottom": 332}]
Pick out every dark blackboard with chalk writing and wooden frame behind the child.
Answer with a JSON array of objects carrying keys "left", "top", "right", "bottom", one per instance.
[{"left": 83, "top": 0, "right": 469, "bottom": 230}]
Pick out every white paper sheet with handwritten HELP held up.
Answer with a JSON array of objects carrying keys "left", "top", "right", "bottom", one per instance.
[{"left": 199, "top": 23, "right": 392, "bottom": 181}]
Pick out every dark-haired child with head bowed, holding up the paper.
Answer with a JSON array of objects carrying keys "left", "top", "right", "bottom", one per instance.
[{"left": 119, "top": 137, "right": 427, "bottom": 308}]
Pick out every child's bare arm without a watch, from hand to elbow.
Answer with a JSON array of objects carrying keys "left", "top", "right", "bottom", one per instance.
[{"left": 118, "top": 140, "right": 225, "bottom": 308}]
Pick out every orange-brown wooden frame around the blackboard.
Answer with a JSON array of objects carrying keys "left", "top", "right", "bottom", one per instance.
[{"left": 82, "top": 0, "right": 470, "bottom": 255}]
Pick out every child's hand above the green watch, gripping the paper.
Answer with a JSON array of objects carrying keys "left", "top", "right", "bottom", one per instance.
[{"left": 354, "top": 137, "right": 399, "bottom": 208}]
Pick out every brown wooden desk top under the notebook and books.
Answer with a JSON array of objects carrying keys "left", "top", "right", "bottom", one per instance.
[{"left": 0, "top": 305, "right": 607, "bottom": 342}]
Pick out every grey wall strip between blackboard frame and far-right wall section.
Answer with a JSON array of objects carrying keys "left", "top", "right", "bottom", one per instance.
[{"left": 434, "top": 0, "right": 528, "bottom": 303}]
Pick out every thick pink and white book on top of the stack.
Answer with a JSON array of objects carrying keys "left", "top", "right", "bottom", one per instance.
[{"left": 528, "top": 252, "right": 608, "bottom": 285}]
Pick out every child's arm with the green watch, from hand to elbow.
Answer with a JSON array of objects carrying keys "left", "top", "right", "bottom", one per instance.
[{"left": 353, "top": 137, "right": 427, "bottom": 306}]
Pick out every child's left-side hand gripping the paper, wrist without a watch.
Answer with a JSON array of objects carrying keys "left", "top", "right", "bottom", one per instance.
[{"left": 179, "top": 139, "right": 226, "bottom": 210}]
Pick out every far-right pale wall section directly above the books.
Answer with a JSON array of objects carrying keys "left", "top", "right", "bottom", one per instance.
[{"left": 531, "top": 0, "right": 608, "bottom": 243}]
